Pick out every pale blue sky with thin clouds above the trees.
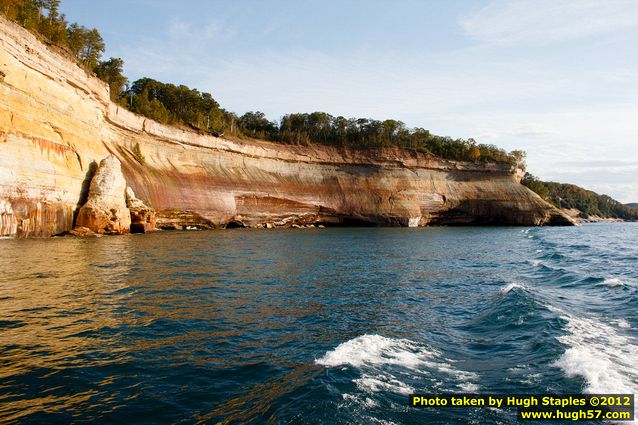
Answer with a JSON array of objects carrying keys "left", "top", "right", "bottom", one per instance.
[{"left": 62, "top": 0, "right": 638, "bottom": 202}]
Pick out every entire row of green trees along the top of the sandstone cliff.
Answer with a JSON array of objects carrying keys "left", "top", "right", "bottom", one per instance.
[{"left": 0, "top": 0, "right": 525, "bottom": 167}]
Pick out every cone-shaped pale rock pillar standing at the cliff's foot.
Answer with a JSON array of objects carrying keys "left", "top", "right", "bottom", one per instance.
[{"left": 76, "top": 155, "right": 131, "bottom": 235}]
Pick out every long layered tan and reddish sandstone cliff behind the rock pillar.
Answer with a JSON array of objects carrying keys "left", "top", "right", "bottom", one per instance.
[{"left": 0, "top": 18, "right": 572, "bottom": 236}]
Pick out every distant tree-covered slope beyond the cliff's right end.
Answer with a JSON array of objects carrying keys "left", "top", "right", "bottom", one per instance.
[{"left": 522, "top": 173, "right": 638, "bottom": 220}]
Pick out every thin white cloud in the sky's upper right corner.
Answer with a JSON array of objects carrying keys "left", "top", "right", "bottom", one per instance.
[{"left": 461, "top": 0, "right": 638, "bottom": 44}]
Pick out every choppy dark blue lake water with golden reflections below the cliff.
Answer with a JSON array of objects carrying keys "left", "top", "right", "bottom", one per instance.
[{"left": 0, "top": 223, "right": 638, "bottom": 424}]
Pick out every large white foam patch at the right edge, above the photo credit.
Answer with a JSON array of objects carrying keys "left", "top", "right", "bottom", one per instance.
[{"left": 554, "top": 309, "right": 638, "bottom": 423}]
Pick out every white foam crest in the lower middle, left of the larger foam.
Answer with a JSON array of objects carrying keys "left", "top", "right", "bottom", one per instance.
[{"left": 316, "top": 335, "right": 437, "bottom": 368}]
